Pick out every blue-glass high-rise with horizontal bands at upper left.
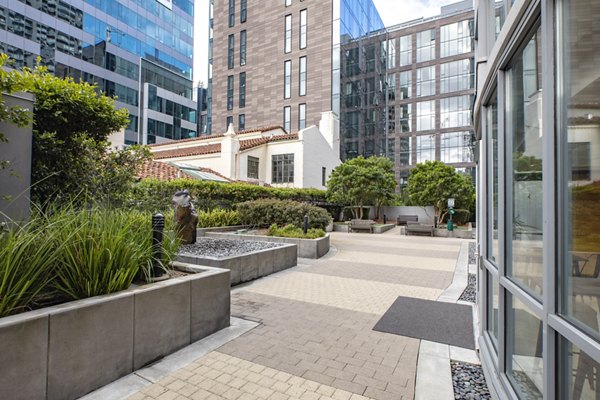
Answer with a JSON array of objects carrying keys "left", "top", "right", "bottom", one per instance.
[{"left": 0, "top": 0, "right": 197, "bottom": 143}]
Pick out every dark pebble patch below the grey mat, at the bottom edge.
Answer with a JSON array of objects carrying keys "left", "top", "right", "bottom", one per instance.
[{"left": 450, "top": 360, "right": 492, "bottom": 400}]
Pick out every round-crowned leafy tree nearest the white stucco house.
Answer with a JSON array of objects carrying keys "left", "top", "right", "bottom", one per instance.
[{"left": 327, "top": 156, "right": 397, "bottom": 219}]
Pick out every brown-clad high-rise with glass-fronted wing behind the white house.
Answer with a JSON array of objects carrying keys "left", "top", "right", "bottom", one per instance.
[{"left": 208, "top": 0, "right": 474, "bottom": 191}]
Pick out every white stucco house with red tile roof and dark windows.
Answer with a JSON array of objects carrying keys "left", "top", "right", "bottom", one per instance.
[{"left": 150, "top": 112, "right": 341, "bottom": 189}]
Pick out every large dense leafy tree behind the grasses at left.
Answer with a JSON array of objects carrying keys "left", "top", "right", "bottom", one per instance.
[{"left": 22, "top": 63, "right": 138, "bottom": 204}]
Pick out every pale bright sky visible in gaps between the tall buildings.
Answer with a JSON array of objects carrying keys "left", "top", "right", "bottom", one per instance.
[{"left": 194, "top": 0, "right": 459, "bottom": 86}]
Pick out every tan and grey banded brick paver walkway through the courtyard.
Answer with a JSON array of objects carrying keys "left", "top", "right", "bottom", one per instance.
[{"left": 130, "top": 231, "right": 462, "bottom": 400}]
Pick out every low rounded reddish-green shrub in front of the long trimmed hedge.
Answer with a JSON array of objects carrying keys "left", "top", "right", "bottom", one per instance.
[{"left": 237, "top": 199, "right": 331, "bottom": 229}]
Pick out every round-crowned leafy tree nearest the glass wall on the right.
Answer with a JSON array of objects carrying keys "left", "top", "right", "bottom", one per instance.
[{"left": 407, "top": 161, "right": 475, "bottom": 222}]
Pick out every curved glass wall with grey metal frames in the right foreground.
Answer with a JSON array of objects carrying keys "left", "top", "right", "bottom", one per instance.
[{"left": 474, "top": 0, "right": 600, "bottom": 400}]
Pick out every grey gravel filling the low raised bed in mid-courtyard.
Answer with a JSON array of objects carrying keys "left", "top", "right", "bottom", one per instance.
[{"left": 179, "top": 237, "right": 281, "bottom": 258}]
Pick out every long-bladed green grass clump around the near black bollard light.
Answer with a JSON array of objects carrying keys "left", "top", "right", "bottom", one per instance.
[{"left": 47, "top": 208, "right": 179, "bottom": 300}]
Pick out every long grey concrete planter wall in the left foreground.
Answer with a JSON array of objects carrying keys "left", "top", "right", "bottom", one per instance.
[{"left": 0, "top": 263, "right": 230, "bottom": 400}]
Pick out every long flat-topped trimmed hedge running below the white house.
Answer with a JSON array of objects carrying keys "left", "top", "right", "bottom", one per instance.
[{"left": 128, "top": 179, "right": 326, "bottom": 212}]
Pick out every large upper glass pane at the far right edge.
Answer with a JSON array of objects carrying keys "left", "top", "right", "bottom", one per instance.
[{"left": 559, "top": 0, "right": 600, "bottom": 340}]
